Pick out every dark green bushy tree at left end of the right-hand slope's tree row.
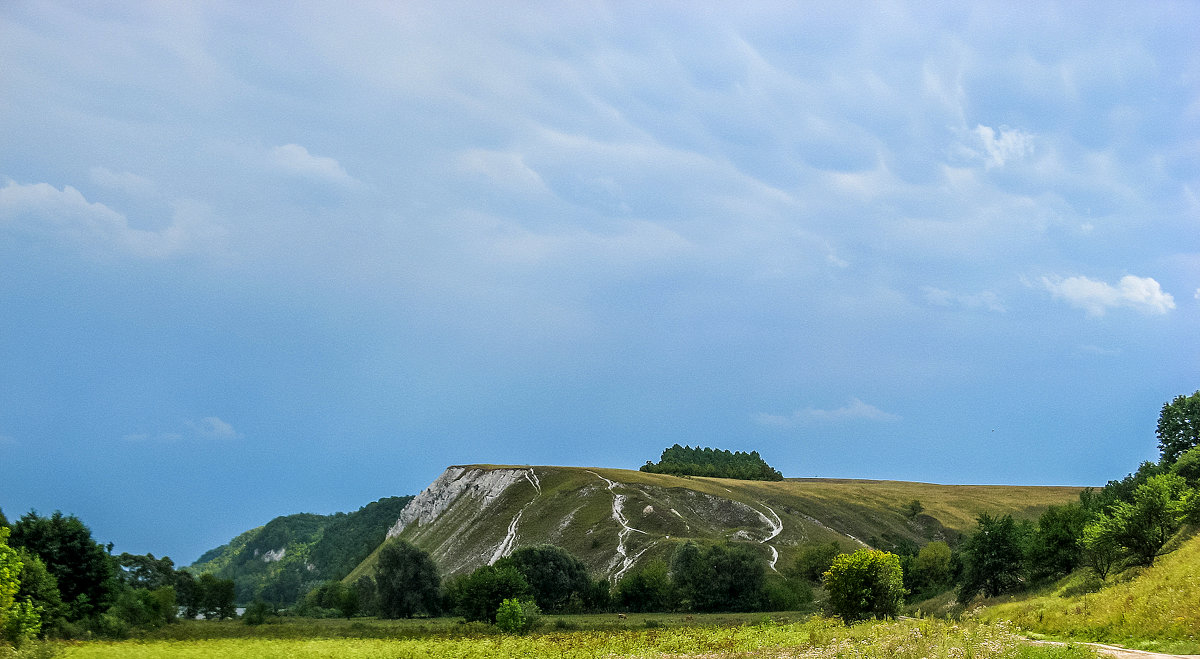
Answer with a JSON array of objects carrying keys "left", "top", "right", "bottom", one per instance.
[{"left": 959, "top": 513, "right": 1028, "bottom": 603}]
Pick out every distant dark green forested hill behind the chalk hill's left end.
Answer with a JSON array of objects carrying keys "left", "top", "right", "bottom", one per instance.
[{"left": 188, "top": 496, "right": 413, "bottom": 603}]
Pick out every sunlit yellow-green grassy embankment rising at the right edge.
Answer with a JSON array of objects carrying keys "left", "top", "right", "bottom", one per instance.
[{"left": 978, "top": 528, "right": 1200, "bottom": 654}]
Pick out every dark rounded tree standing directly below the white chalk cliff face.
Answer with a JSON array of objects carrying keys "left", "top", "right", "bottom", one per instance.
[{"left": 374, "top": 538, "right": 442, "bottom": 618}]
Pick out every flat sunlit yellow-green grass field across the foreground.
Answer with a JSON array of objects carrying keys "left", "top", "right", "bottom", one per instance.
[{"left": 42, "top": 616, "right": 1094, "bottom": 659}]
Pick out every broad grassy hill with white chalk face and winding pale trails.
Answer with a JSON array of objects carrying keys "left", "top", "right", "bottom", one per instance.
[{"left": 347, "top": 465, "right": 1079, "bottom": 581}]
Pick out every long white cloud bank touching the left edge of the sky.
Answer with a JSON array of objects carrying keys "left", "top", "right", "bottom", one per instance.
[{"left": 0, "top": 180, "right": 224, "bottom": 259}]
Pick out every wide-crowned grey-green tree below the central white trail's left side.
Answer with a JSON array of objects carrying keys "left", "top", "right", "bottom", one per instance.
[{"left": 496, "top": 545, "right": 594, "bottom": 613}]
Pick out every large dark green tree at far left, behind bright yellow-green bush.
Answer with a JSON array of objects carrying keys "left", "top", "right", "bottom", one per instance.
[{"left": 10, "top": 511, "right": 120, "bottom": 621}]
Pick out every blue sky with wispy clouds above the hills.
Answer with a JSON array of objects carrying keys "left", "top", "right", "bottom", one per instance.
[{"left": 0, "top": 0, "right": 1200, "bottom": 564}]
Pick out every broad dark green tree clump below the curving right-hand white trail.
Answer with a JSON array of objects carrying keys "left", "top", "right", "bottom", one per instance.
[{"left": 671, "top": 541, "right": 767, "bottom": 611}]
